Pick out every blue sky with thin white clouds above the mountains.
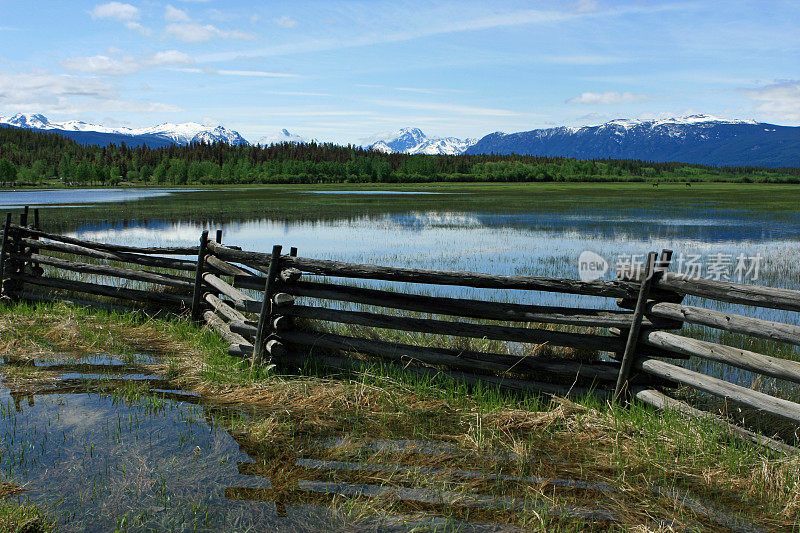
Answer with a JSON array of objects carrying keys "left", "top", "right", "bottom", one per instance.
[{"left": 0, "top": 0, "right": 800, "bottom": 143}]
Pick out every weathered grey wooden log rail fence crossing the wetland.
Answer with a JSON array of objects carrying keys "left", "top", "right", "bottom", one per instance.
[{"left": 0, "top": 208, "right": 800, "bottom": 449}]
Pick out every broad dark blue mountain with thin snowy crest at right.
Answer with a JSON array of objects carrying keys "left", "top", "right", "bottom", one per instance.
[{"left": 466, "top": 115, "right": 800, "bottom": 167}]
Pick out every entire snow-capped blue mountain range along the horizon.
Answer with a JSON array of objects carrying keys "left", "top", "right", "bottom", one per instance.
[{"left": 0, "top": 114, "right": 800, "bottom": 167}]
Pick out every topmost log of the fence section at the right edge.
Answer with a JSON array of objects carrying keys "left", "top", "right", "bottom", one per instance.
[{"left": 634, "top": 271, "right": 800, "bottom": 311}]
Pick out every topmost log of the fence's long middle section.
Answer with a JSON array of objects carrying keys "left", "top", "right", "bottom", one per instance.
[{"left": 205, "top": 243, "right": 639, "bottom": 298}]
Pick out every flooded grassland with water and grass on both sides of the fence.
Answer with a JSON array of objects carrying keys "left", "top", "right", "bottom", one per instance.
[{"left": 0, "top": 184, "right": 800, "bottom": 531}]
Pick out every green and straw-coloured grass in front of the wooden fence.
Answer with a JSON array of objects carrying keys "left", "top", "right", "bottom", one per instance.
[{"left": 0, "top": 304, "right": 800, "bottom": 531}]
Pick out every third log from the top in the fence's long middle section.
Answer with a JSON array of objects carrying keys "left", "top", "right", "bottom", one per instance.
[{"left": 282, "top": 305, "right": 622, "bottom": 351}]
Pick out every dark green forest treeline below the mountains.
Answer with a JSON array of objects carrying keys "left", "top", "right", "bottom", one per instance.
[{"left": 0, "top": 127, "right": 800, "bottom": 186}]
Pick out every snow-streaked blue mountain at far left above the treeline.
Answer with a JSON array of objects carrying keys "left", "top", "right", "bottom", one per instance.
[{"left": 0, "top": 114, "right": 248, "bottom": 146}]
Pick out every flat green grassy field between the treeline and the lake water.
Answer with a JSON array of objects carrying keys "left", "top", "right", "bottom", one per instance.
[{"left": 4, "top": 183, "right": 800, "bottom": 231}]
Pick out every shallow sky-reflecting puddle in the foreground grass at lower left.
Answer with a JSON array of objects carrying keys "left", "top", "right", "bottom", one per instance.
[{"left": 0, "top": 358, "right": 592, "bottom": 531}]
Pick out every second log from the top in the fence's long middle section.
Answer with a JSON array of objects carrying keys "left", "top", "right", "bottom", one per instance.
[{"left": 270, "top": 281, "right": 652, "bottom": 327}]
